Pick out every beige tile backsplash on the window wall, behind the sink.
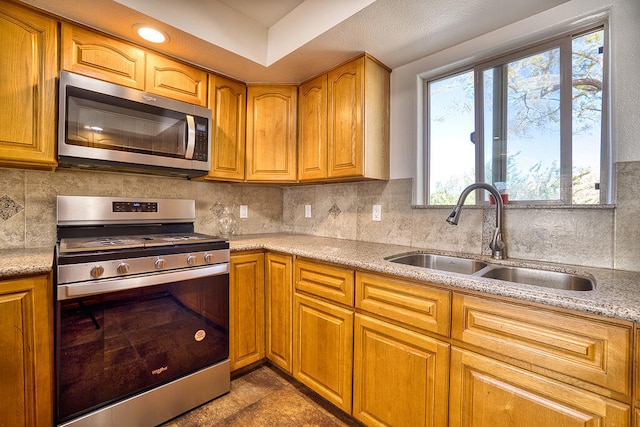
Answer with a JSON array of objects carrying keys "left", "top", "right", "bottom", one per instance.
[{"left": 283, "top": 162, "right": 640, "bottom": 271}]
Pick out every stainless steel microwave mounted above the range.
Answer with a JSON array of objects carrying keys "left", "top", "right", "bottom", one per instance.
[{"left": 58, "top": 71, "right": 212, "bottom": 177}]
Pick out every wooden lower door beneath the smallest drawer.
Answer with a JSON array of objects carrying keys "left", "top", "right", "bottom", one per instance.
[{"left": 293, "top": 293, "right": 353, "bottom": 413}]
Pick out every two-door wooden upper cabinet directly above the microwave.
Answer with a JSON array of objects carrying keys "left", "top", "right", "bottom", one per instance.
[{"left": 61, "top": 23, "right": 207, "bottom": 106}]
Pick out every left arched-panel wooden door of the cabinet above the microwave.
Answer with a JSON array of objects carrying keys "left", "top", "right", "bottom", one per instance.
[{"left": 61, "top": 23, "right": 145, "bottom": 90}]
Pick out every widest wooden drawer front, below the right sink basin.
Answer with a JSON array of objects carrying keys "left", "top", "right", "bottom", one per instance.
[{"left": 451, "top": 293, "right": 632, "bottom": 396}]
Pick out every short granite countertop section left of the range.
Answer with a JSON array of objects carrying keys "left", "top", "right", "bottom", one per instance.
[{"left": 0, "top": 247, "right": 53, "bottom": 280}]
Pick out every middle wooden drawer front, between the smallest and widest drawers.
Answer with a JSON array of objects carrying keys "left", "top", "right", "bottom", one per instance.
[{"left": 356, "top": 273, "right": 451, "bottom": 336}]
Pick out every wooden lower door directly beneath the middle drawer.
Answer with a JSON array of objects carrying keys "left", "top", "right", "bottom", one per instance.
[{"left": 353, "top": 314, "right": 449, "bottom": 427}]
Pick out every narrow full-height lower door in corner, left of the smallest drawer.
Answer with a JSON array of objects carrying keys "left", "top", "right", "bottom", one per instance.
[{"left": 266, "top": 253, "right": 293, "bottom": 373}]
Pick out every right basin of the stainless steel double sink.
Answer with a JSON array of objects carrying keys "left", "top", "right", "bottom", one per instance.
[{"left": 479, "top": 267, "right": 594, "bottom": 291}]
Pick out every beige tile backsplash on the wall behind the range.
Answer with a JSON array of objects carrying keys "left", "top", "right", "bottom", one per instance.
[{"left": 0, "top": 168, "right": 282, "bottom": 249}]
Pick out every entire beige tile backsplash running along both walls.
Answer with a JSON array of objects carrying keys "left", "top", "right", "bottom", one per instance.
[{"left": 0, "top": 162, "right": 640, "bottom": 271}]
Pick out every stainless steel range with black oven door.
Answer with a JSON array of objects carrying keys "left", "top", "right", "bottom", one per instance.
[{"left": 55, "top": 196, "right": 230, "bottom": 426}]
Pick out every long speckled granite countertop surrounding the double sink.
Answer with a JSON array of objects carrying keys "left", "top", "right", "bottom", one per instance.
[{"left": 230, "top": 234, "right": 640, "bottom": 322}]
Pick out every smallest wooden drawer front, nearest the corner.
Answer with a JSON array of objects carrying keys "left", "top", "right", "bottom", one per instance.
[{"left": 295, "top": 260, "right": 354, "bottom": 307}]
